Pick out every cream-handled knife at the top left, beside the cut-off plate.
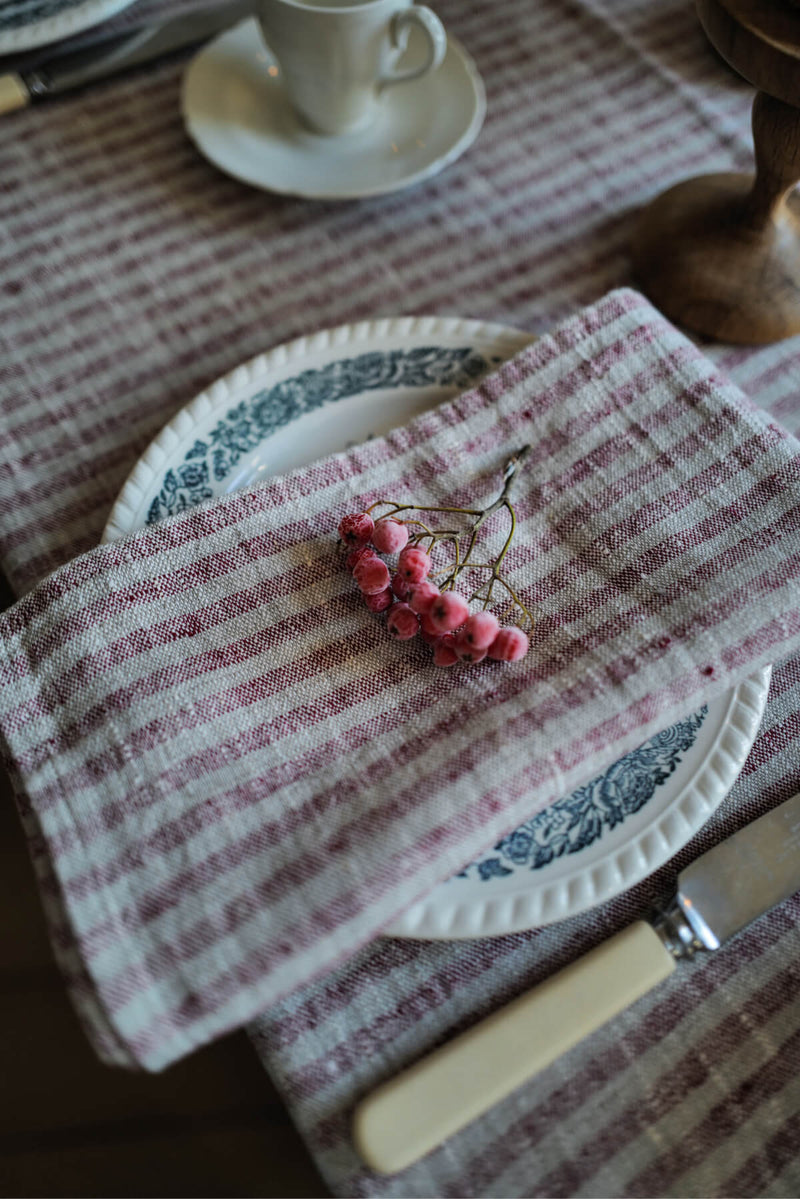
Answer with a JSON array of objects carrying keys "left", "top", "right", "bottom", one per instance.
[{"left": 0, "top": 0, "right": 255, "bottom": 115}]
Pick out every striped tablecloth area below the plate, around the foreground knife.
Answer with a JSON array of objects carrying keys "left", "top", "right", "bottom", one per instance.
[{"left": 251, "top": 659, "right": 800, "bottom": 1199}]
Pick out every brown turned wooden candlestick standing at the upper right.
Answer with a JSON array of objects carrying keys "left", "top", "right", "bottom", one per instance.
[{"left": 632, "top": 0, "right": 800, "bottom": 344}]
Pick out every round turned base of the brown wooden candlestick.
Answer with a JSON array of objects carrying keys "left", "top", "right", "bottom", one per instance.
[{"left": 632, "top": 174, "right": 800, "bottom": 345}]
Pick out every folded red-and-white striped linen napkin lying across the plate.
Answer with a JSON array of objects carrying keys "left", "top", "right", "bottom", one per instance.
[{"left": 0, "top": 291, "right": 800, "bottom": 1070}]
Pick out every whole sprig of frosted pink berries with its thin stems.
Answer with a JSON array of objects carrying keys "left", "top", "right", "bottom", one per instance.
[{"left": 338, "top": 446, "right": 534, "bottom": 667}]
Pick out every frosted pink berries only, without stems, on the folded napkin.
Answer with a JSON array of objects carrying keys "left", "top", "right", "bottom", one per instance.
[{"left": 339, "top": 512, "right": 529, "bottom": 667}]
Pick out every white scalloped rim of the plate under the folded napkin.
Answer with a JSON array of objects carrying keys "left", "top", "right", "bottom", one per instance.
[{"left": 102, "top": 315, "right": 771, "bottom": 940}]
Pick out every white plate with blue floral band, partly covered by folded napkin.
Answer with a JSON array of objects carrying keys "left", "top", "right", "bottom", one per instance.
[{"left": 104, "top": 317, "right": 770, "bottom": 938}]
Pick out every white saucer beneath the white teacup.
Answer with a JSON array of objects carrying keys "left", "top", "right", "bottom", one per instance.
[{"left": 182, "top": 19, "right": 486, "bottom": 200}]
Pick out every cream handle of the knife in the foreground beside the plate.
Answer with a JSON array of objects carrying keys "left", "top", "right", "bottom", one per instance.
[{"left": 354, "top": 921, "right": 675, "bottom": 1174}]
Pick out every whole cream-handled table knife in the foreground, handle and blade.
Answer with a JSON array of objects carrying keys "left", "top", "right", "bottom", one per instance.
[{"left": 353, "top": 794, "right": 800, "bottom": 1174}]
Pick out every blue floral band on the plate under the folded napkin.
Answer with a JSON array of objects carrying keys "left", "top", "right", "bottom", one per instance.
[{"left": 146, "top": 345, "right": 708, "bottom": 882}]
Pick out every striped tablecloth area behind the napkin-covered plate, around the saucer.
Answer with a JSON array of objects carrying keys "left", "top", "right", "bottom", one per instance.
[{"left": 0, "top": 0, "right": 767, "bottom": 591}]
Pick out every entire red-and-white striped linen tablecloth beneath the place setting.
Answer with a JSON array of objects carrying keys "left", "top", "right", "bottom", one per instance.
[{"left": 0, "top": 0, "right": 800, "bottom": 1195}]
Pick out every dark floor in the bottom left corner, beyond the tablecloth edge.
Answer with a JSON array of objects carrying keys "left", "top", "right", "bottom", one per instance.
[{"left": 0, "top": 570, "right": 329, "bottom": 1199}]
